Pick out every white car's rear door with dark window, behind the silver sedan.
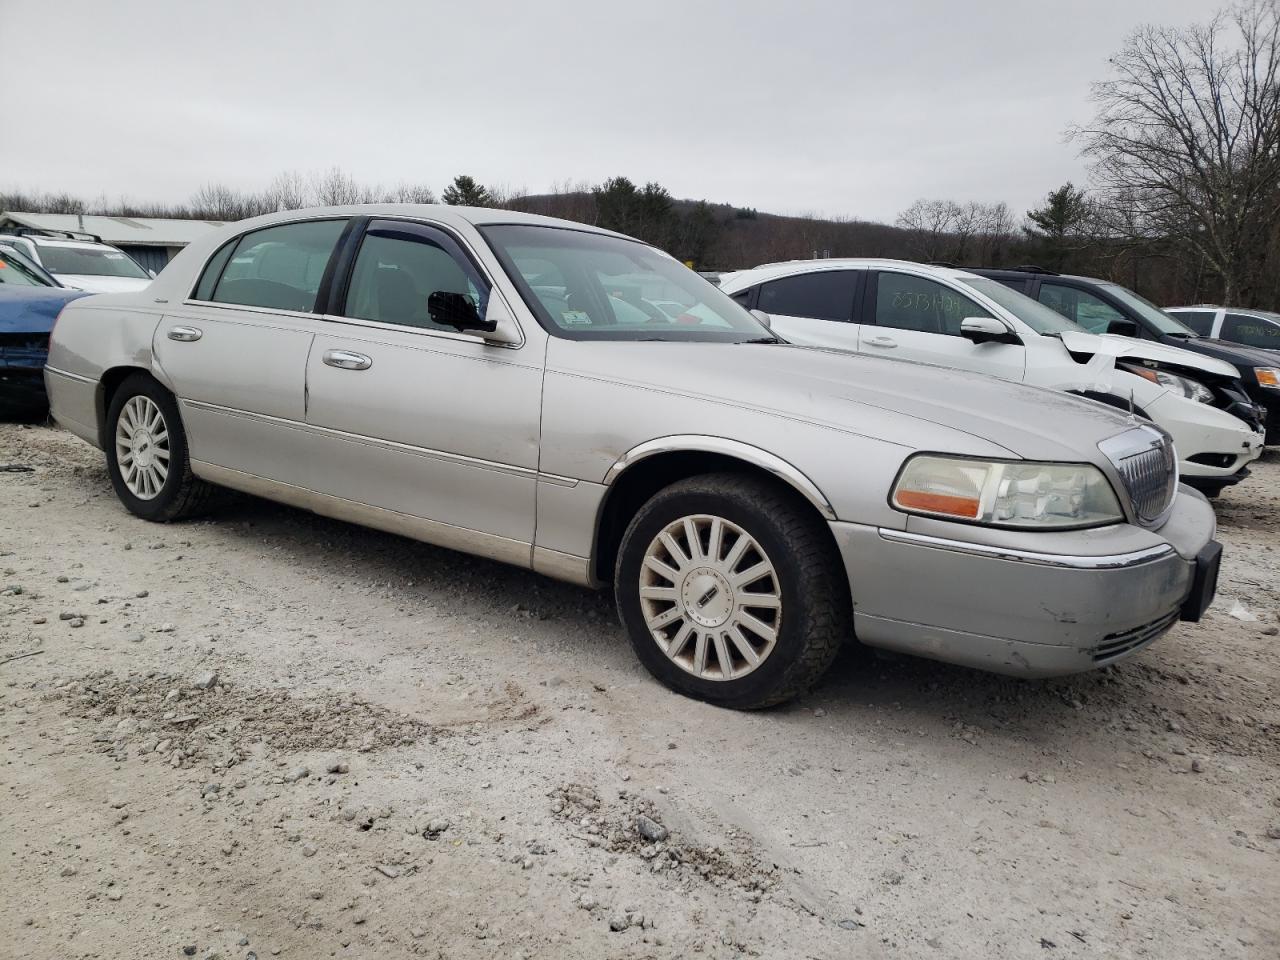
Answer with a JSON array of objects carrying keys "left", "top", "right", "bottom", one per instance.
[{"left": 755, "top": 270, "right": 865, "bottom": 351}]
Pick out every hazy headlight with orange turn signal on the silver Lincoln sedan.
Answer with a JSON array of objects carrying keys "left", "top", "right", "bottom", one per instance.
[{"left": 892, "top": 453, "right": 1124, "bottom": 529}]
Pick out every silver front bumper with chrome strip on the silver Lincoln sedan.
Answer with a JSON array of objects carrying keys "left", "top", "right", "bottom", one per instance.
[{"left": 831, "top": 490, "right": 1216, "bottom": 677}]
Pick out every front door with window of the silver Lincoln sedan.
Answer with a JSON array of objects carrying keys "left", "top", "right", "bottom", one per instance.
[{"left": 306, "top": 220, "right": 543, "bottom": 564}]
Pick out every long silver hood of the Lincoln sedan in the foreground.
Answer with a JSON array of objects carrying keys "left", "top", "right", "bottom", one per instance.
[{"left": 548, "top": 340, "right": 1132, "bottom": 462}]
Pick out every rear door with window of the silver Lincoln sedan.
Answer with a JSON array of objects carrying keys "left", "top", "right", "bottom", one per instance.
[{"left": 152, "top": 218, "right": 348, "bottom": 486}]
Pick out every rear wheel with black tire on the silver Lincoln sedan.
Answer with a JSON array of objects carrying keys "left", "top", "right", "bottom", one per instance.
[{"left": 104, "top": 374, "right": 211, "bottom": 522}]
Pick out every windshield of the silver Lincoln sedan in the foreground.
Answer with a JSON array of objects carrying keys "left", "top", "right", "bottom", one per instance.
[{"left": 480, "top": 225, "right": 774, "bottom": 343}]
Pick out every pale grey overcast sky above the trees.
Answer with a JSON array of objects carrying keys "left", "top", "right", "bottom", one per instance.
[{"left": 0, "top": 0, "right": 1216, "bottom": 220}]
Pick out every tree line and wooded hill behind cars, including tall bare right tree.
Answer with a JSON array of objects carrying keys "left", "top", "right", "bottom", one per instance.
[{"left": 0, "top": 0, "right": 1280, "bottom": 307}]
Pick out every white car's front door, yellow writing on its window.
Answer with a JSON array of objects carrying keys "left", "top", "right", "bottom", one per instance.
[{"left": 860, "top": 270, "right": 1027, "bottom": 381}]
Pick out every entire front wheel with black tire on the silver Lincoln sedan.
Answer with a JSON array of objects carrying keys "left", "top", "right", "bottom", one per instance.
[{"left": 614, "top": 474, "right": 852, "bottom": 709}]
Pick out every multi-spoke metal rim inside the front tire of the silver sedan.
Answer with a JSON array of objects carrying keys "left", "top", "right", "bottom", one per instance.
[{"left": 640, "top": 513, "right": 782, "bottom": 680}]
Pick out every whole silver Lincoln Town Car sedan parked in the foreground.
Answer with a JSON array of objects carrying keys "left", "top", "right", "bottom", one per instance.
[{"left": 46, "top": 205, "right": 1221, "bottom": 708}]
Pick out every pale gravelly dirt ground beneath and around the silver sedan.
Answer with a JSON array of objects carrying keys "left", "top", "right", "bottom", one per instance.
[{"left": 0, "top": 425, "right": 1280, "bottom": 960}]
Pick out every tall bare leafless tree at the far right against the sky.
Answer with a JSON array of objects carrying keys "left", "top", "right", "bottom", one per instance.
[{"left": 1073, "top": 0, "right": 1280, "bottom": 303}]
